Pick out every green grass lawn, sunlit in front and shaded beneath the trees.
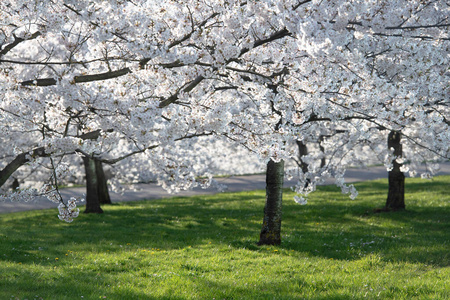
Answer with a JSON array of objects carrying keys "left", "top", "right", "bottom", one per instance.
[{"left": 0, "top": 176, "right": 450, "bottom": 299}]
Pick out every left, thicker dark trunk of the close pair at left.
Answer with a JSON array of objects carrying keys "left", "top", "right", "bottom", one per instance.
[{"left": 83, "top": 156, "right": 103, "bottom": 214}]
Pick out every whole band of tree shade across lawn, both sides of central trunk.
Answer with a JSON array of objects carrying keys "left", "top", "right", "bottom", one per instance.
[{"left": 0, "top": 181, "right": 450, "bottom": 267}]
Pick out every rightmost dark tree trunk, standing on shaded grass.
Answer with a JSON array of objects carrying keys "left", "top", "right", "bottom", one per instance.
[{"left": 385, "top": 130, "right": 405, "bottom": 211}]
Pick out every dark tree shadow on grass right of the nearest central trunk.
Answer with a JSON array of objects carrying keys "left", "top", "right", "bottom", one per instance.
[{"left": 283, "top": 205, "right": 450, "bottom": 267}]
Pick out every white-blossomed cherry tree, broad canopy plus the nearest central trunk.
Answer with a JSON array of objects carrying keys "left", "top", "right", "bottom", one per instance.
[{"left": 0, "top": 0, "right": 450, "bottom": 244}]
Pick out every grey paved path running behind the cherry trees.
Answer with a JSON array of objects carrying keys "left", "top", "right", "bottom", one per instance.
[{"left": 0, "top": 162, "right": 450, "bottom": 214}]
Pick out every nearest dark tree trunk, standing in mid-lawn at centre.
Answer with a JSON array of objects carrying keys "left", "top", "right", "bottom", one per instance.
[{"left": 258, "top": 160, "right": 284, "bottom": 245}]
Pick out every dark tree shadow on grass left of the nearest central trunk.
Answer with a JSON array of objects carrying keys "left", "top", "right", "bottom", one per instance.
[{"left": 0, "top": 194, "right": 262, "bottom": 262}]
